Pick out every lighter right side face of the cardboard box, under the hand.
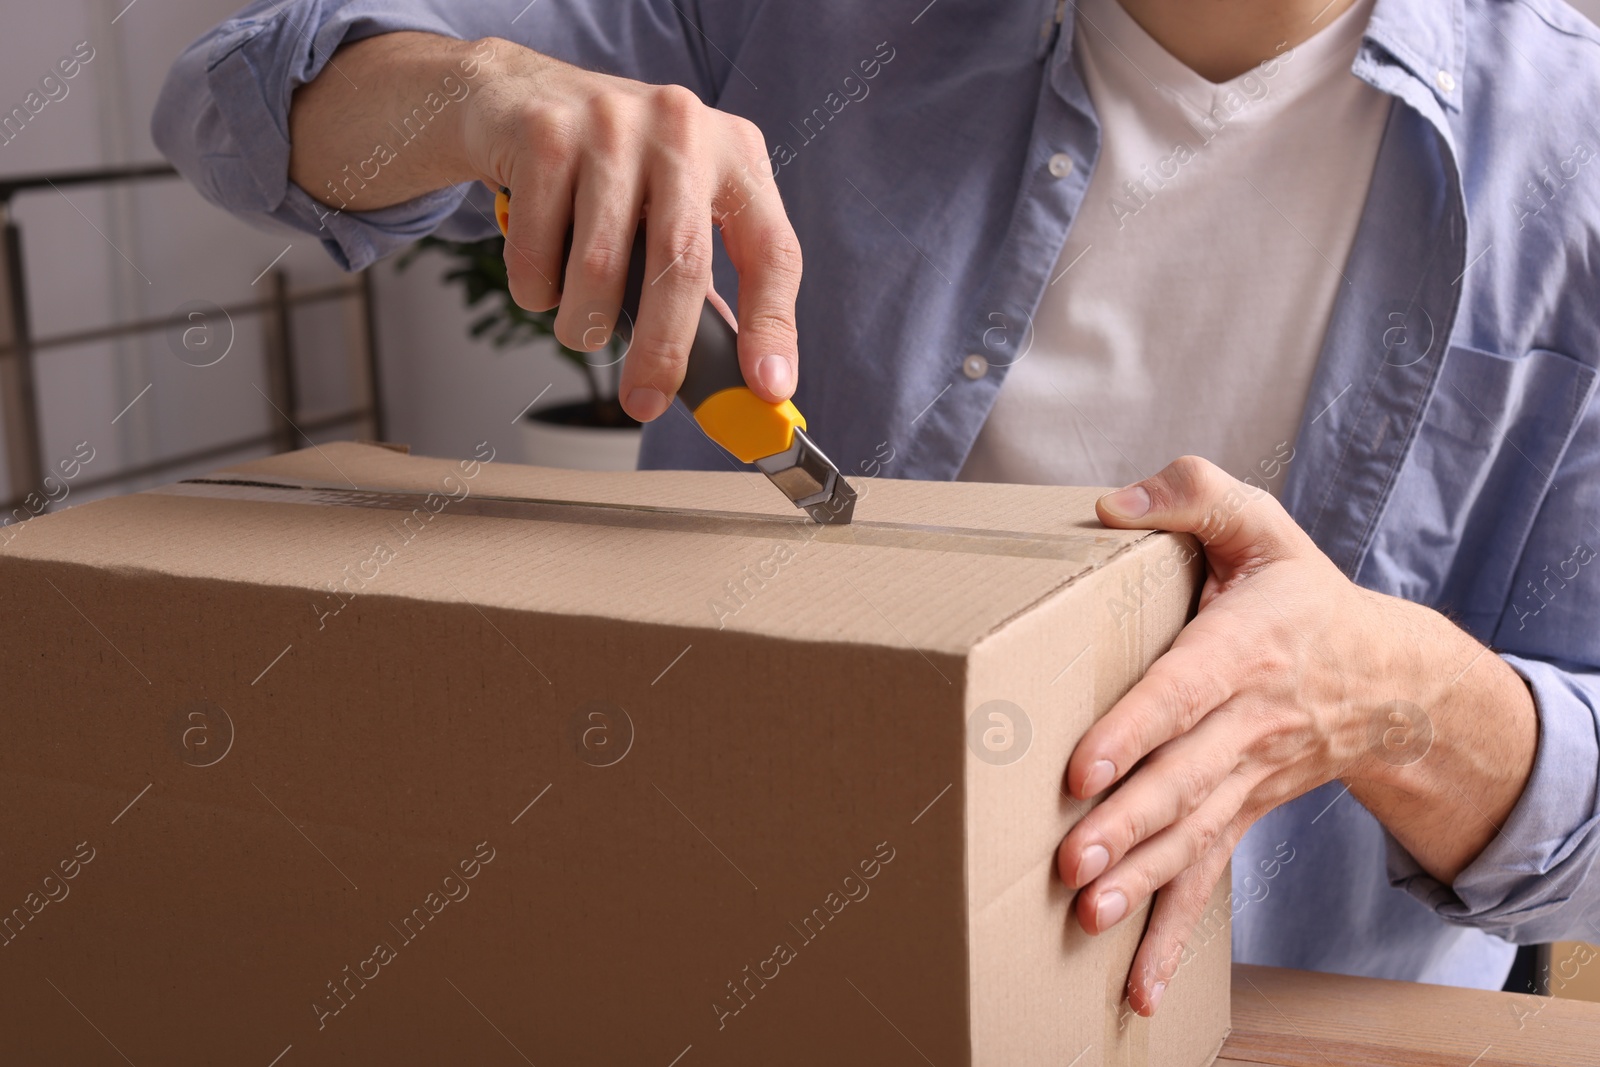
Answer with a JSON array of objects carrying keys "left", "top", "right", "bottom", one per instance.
[{"left": 966, "top": 537, "right": 1232, "bottom": 1067}]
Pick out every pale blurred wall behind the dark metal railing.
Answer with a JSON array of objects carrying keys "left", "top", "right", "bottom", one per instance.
[{"left": 0, "top": 0, "right": 582, "bottom": 499}]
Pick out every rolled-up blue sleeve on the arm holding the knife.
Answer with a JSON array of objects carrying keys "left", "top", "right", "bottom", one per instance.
[{"left": 150, "top": 0, "right": 757, "bottom": 270}]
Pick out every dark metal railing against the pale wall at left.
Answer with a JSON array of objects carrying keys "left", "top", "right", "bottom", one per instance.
[{"left": 0, "top": 163, "right": 384, "bottom": 525}]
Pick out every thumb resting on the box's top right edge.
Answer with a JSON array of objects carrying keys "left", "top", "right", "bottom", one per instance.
[{"left": 1094, "top": 456, "right": 1306, "bottom": 565}]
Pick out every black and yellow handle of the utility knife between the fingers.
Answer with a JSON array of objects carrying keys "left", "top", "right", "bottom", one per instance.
[{"left": 494, "top": 189, "right": 805, "bottom": 462}]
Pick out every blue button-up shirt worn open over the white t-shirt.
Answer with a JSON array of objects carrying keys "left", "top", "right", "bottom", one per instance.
[{"left": 154, "top": 0, "right": 1600, "bottom": 987}]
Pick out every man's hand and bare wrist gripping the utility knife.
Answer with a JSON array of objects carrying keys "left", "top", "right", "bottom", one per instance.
[{"left": 290, "top": 34, "right": 800, "bottom": 421}]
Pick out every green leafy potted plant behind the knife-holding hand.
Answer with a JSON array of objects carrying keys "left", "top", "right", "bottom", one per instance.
[{"left": 395, "top": 235, "right": 637, "bottom": 426}]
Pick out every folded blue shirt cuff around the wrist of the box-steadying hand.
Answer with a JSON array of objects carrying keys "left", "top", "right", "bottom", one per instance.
[{"left": 1384, "top": 656, "right": 1600, "bottom": 944}]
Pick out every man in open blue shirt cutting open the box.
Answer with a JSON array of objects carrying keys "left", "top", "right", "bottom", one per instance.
[{"left": 155, "top": 0, "right": 1600, "bottom": 1014}]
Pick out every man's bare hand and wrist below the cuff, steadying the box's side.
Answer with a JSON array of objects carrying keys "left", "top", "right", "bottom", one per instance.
[{"left": 1056, "top": 458, "right": 1536, "bottom": 1014}]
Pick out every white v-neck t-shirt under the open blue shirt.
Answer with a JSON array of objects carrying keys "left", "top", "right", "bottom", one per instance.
[{"left": 960, "top": 0, "right": 1389, "bottom": 493}]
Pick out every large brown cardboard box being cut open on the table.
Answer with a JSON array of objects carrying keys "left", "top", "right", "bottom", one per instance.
[{"left": 0, "top": 445, "right": 1229, "bottom": 1067}]
